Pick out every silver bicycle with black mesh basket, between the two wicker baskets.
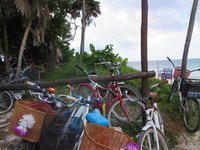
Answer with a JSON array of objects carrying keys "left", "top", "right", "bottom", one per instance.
[{"left": 15, "top": 81, "right": 108, "bottom": 150}]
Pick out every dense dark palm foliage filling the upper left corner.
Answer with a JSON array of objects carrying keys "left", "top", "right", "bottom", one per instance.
[{"left": 0, "top": 0, "right": 101, "bottom": 74}]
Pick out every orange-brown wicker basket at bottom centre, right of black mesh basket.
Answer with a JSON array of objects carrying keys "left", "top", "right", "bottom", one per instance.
[{"left": 80, "top": 123, "right": 133, "bottom": 150}]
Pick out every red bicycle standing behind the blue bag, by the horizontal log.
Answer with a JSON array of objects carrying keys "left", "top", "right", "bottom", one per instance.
[{"left": 76, "top": 65, "right": 144, "bottom": 126}]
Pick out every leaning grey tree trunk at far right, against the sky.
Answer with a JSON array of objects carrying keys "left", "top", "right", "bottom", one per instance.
[{"left": 181, "top": 0, "right": 198, "bottom": 77}]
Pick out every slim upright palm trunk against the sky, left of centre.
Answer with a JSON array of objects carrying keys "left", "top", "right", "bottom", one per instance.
[{"left": 80, "top": 0, "right": 86, "bottom": 58}]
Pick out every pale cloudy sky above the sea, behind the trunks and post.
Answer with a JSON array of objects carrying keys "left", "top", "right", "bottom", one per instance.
[{"left": 71, "top": 0, "right": 200, "bottom": 61}]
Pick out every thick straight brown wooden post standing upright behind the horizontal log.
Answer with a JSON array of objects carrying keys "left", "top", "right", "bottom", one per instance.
[{"left": 141, "top": 0, "right": 148, "bottom": 97}]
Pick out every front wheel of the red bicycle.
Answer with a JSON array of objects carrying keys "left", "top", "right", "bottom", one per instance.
[{"left": 107, "top": 98, "right": 144, "bottom": 126}]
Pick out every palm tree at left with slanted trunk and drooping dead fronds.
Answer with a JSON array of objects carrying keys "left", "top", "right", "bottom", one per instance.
[{"left": 15, "top": 0, "right": 49, "bottom": 78}]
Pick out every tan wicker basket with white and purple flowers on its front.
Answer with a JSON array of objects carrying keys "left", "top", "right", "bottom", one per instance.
[{"left": 9, "top": 100, "right": 56, "bottom": 142}]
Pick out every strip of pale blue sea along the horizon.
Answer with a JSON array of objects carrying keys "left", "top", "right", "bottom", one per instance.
[{"left": 128, "top": 58, "right": 200, "bottom": 79}]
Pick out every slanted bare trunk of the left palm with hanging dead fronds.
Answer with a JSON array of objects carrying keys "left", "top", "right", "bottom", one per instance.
[{"left": 16, "top": 19, "right": 32, "bottom": 78}]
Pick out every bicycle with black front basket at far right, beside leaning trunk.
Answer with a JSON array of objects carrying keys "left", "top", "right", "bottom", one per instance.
[{"left": 167, "top": 57, "right": 200, "bottom": 133}]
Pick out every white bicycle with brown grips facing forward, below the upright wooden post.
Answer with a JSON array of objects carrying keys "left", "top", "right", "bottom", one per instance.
[{"left": 138, "top": 80, "right": 169, "bottom": 150}]
